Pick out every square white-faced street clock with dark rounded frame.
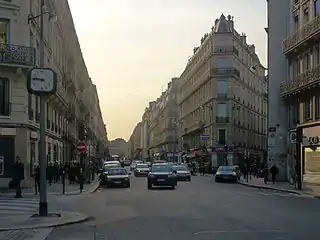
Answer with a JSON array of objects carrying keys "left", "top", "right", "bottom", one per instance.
[{"left": 27, "top": 68, "right": 57, "bottom": 94}]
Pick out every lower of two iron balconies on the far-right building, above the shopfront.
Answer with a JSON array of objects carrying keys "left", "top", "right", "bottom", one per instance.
[{"left": 280, "top": 65, "right": 320, "bottom": 98}]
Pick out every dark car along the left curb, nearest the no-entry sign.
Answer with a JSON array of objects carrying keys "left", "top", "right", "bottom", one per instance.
[{"left": 101, "top": 168, "right": 130, "bottom": 188}]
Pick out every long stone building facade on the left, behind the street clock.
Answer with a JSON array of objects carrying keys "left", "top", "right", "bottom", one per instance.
[{"left": 0, "top": 0, "right": 107, "bottom": 186}]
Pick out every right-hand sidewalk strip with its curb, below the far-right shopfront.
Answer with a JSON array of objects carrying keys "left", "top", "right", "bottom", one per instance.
[{"left": 238, "top": 177, "right": 320, "bottom": 198}]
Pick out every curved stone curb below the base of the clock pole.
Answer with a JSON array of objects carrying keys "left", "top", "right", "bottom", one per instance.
[{"left": 0, "top": 214, "right": 94, "bottom": 232}]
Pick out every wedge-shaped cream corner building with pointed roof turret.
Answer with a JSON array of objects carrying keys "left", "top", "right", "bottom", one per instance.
[{"left": 178, "top": 15, "right": 267, "bottom": 165}]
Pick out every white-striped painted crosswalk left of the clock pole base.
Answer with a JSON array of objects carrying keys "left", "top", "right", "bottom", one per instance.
[{"left": 0, "top": 197, "right": 39, "bottom": 215}]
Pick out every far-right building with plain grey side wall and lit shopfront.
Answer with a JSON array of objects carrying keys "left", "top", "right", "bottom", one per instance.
[{"left": 276, "top": 0, "right": 320, "bottom": 184}]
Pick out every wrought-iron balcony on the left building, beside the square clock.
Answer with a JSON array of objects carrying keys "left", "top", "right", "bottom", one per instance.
[{"left": 0, "top": 43, "right": 36, "bottom": 66}]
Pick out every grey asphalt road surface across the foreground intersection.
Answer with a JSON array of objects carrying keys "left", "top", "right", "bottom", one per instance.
[{"left": 47, "top": 173, "right": 320, "bottom": 240}]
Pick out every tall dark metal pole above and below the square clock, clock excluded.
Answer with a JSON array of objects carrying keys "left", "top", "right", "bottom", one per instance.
[{"left": 39, "top": 0, "right": 48, "bottom": 217}]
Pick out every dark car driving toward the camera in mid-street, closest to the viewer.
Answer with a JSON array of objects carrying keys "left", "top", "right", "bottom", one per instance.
[{"left": 148, "top": 163, "right": 177, "bottom": 189}]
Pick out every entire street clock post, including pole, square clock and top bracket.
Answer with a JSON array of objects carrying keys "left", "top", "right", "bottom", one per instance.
[{"left": 27, "top": 0, "right": 57, "bottom": 217}]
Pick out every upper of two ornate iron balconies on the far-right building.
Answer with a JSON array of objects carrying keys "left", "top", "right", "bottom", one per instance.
[{"left": 283, "top": 15, "right": 320, "bottom": 54}]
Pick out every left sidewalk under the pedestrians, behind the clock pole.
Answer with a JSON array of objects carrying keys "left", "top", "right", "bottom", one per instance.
[{"left": 0, "top": 176, "right": 99, "bottom": 196}]
